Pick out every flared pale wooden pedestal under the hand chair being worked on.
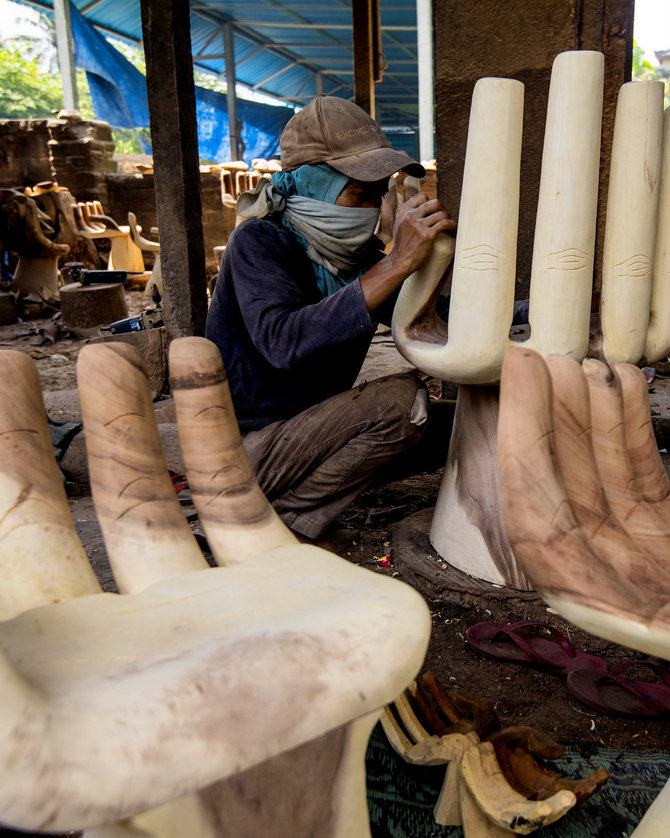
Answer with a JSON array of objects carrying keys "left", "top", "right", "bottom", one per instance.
[{"left": 430, "top": 385, "right": 532, "bottom": 590}]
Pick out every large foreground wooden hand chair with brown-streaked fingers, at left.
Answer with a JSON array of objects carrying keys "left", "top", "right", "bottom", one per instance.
[{"left": 0, "top": 338, "right": 430, "bottom": 838}]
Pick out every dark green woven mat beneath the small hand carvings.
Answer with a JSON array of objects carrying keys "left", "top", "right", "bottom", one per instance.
[{"left": 367, "top": 725, "right": 670, "bottom": 838}]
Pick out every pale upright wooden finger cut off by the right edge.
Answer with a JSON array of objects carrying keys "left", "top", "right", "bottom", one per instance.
[{"left": 644, "top": 108, "right": 670, "bottom": 364}]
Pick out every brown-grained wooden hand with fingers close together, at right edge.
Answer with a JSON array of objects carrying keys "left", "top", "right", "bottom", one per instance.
[{"left": 498, "top": 348, "right": 670, "bottom": 838}]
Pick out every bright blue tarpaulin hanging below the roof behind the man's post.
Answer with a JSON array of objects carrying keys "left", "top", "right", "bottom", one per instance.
[{"left": 70, "top": 5, "right": 293, "bottom": 163}]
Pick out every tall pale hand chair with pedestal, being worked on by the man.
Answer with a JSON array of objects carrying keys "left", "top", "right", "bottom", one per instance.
[{"left": 393, "top": 51, "right": 670, "bottom": 588}]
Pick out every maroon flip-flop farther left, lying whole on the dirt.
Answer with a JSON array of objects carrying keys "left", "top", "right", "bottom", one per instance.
[{"left": 466, "top": 621, "right": 607, "bottom": 675}]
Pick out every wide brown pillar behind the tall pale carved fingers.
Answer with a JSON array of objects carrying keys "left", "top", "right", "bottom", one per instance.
[{"left": 434, "top": 0, "right": 634, "bottom": 298}]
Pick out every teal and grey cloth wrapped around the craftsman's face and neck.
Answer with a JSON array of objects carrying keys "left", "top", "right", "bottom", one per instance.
[{"left": 237, "top": 163, "right": 379, "bottom": 297}]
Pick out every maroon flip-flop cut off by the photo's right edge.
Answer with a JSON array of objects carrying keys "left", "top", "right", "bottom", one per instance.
[{"left": 568, "top": 660, "right": 670, "bottom": 718}]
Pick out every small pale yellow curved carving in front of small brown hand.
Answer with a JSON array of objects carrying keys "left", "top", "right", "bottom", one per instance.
[{"left": 461, "top": 742, "right": 577, "bottom": 835}]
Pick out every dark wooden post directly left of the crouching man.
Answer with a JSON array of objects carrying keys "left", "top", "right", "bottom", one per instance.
[{"left": 141, "top": 0, "right": 207, "bottom": 340}]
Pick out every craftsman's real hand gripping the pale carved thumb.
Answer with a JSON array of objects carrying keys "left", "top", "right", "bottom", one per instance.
[{"left": 389, "top": 192, "right": 456, "bottom": 277}]
